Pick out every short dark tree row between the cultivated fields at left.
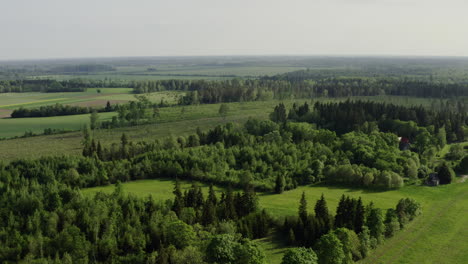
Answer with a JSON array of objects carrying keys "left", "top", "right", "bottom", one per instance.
[{"left": 11, "top": 102, "right": 115, "bottom": 118}]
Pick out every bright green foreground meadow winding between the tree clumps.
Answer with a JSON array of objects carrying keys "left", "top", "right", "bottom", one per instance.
[{"left": 83, "top": 179, "right": 468, "bottom": 264}]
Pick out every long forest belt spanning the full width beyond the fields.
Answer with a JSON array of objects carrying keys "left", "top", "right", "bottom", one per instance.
[{"left": 0, "top": 75, "right": 468, "bottom": 99}]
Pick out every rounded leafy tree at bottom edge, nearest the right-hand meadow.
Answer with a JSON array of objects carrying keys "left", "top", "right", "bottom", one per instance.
[{"left": 317, "top": 233, "right": 345, "bottom": 264}]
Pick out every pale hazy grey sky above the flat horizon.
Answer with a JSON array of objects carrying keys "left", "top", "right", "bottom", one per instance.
[{"left": 0, "top": 0, "right": 468, "bottom": 60}]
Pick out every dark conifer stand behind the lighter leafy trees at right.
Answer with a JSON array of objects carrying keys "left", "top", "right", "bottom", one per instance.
[{"left": 280, "top": 100, "right": 468, "bottom": 143}]
